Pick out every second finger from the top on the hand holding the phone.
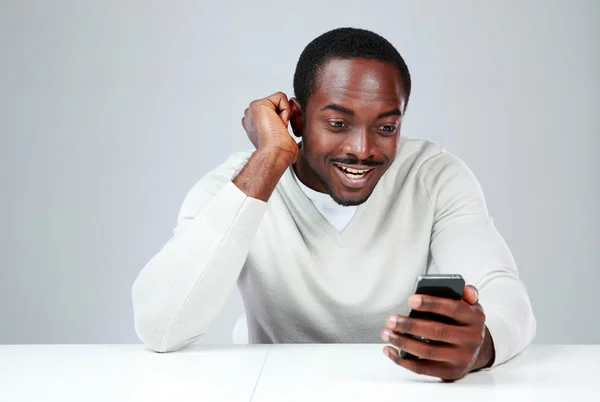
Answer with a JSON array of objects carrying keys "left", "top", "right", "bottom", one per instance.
[{"left": 386, "top": 315, "right": 475, "bottom": 345}]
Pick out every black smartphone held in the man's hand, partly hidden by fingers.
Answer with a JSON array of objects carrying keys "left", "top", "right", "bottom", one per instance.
[{"left": 400, "top": 274, "right": 465, "bottom": 359}]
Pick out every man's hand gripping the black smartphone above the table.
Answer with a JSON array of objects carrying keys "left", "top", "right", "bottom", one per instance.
[{"left": 381, "top": 286, "right": 494, "bottom": 381}]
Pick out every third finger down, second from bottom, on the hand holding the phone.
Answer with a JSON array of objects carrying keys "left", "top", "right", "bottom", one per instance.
[{"left": 381, "top": 328, "right": 460, "bottom": 362}]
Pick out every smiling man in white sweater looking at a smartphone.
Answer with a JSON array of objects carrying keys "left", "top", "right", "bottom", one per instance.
[{"left": 133, "top": 28, "right": 535, "bottom": 380}]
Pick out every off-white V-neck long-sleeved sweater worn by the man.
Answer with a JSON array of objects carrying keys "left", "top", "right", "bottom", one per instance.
[{"left": 132, "top": 138, "right": 535, "bottom": 365}]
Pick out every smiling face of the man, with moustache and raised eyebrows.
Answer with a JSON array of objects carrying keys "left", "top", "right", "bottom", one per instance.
[{"left": 291, "top": 59, "right": 405, "bottom": 205}]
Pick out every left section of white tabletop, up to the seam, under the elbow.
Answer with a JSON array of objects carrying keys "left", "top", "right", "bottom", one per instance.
[{"left": 0, "top": 345, "right": 269, "bottom": 402}]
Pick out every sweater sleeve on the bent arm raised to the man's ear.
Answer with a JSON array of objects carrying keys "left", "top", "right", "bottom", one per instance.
[{"left": 132, "top": 154, "right": 267, "bottom": 352}]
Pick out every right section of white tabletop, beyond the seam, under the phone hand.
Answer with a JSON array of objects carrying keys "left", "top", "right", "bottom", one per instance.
[{"left": 252, "top": 345, "right": 600, "bottom": 402}]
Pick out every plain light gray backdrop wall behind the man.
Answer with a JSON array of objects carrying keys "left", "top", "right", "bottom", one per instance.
[{"left": 0, "top": 0, "right": 600, "bottom": 343}]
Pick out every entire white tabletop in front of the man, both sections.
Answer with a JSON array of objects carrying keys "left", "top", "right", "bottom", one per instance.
[{"left": 0, "top": 345, "right": 600, "bottom": 402}]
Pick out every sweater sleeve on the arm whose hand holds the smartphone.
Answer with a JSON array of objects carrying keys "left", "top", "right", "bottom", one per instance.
[{"left": 422, "top": 152, "right": 536, "bottom": 367}]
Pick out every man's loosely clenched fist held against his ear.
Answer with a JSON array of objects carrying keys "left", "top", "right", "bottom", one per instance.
[{"left": 242, "top": 92, "right": 299, "bottom": 163}]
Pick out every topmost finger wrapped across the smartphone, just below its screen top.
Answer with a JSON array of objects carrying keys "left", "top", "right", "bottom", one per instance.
[{"left": 408, "top": 295, "right": 482, "bottom": 324}]
